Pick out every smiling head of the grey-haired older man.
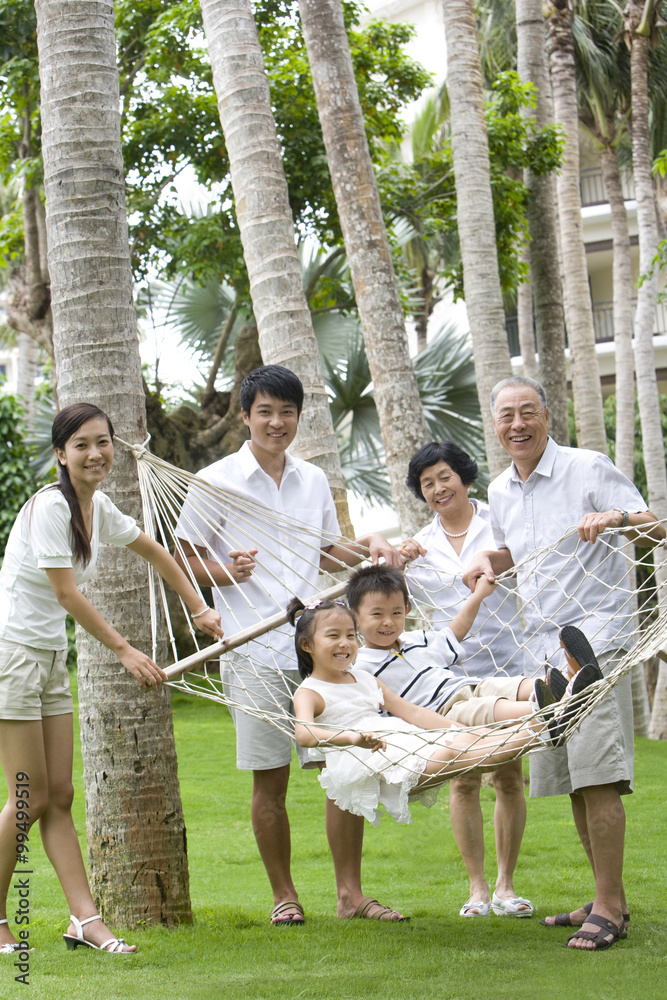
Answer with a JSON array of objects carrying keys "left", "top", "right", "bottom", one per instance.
[{"left": 493, "top": 385, "right": 549, "bottom": 480}]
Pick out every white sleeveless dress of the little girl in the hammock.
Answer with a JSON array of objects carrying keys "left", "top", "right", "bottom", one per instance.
[{"left": 301, "top": 669, "right": 460, "bottom": 826}]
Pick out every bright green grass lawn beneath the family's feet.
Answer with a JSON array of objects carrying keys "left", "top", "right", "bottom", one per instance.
[{"left": 0, "top": 694, "right": 667, "bottom": 1000}]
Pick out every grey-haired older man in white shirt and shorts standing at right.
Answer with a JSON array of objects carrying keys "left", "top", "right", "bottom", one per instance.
[{"left": 464, "top": 377, "right": 665, "bottom": 950}]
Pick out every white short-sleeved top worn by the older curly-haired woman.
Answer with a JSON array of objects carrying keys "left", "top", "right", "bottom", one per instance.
[{"left": 406, "top": 500, "right": 523, "bottom": 677}]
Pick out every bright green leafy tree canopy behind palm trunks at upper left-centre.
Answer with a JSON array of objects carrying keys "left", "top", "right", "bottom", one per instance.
[{"left": 116, "top": 0, "right": 430, "bottom": 290}]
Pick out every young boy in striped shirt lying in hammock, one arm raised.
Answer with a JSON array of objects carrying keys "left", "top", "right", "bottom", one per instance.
[{"left": 347, "top": 566, "right": 535, "bottom": 726}]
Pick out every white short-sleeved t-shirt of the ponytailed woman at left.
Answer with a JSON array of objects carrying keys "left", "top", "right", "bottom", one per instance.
[{"left": 0, "top": 486, "right": 140, "bottom": 649}]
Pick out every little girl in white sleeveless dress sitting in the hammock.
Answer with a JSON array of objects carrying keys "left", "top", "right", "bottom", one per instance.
[{"left": 288, "top": 599, "right": 572, "bottom": 826}]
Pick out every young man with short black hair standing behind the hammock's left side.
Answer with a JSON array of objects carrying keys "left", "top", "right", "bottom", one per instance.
[{"left": 177, "top": 365, "right": 402, "bottom": 924}]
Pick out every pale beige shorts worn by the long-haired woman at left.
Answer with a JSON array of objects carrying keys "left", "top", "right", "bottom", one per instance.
[{"left": 0, "top": 639, "right": 74, "bottom": 722}]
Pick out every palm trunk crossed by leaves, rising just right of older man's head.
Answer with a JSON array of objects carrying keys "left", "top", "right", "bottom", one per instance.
[{"left": 516, "top": 0, "right": 570, "bottom": 445}]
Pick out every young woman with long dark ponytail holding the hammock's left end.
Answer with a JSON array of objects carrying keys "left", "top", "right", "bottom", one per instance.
[{"left": 0, "top": 403, "right": 223, "bottom": 955}]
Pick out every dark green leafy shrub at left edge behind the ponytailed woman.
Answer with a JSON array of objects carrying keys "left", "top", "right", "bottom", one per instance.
[{"left": 0, "top": 384, "right": 35, "bottom": 553}]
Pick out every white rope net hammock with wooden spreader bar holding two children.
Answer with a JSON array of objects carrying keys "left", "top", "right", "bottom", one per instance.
[{"left": 116, "top": 439, "right": 667, "bottom": 787}]
